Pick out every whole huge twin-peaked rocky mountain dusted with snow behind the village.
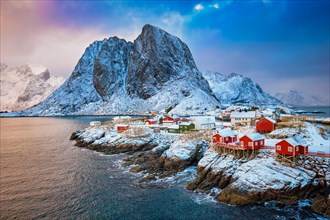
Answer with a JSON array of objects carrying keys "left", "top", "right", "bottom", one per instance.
[{"left": 23, "top": 25, "right": 220, "bottom": 115}]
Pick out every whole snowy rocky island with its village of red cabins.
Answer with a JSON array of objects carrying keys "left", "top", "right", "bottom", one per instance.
[{"left": 71, "top": 111, "right": 330, "bottom": 216}]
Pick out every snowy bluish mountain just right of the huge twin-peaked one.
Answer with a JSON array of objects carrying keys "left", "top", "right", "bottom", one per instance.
[{"left": 203, "top": 71, "right": 281, "bottom": 106}]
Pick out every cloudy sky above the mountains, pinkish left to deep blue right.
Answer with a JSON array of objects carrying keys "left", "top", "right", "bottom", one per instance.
[{"left": 1, "top": 0, "right": 330, "bottom": 99}]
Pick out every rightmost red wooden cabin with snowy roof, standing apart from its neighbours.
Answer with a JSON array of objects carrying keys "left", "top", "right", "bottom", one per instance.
[{"left": 275, "top": 138, "right": 308, "bottom": 156}]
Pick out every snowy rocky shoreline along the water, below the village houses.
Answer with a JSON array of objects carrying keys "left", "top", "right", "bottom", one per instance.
[{"left": 70, "top": 126, "right": 330, "bottom": 217}]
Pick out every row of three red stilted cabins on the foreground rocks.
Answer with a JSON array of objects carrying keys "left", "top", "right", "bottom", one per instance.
[{"left": 212, "top": 129, "right": 308, "bottom": 156}]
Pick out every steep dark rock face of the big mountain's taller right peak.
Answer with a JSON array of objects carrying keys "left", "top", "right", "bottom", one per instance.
[{"left": 126, "top": 25, "right": 210, "bottom": 99}]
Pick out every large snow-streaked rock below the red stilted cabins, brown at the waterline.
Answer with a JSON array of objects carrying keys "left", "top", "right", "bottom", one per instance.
[{"left": 186, "top": 149, "right": 329, "bottom": 205}]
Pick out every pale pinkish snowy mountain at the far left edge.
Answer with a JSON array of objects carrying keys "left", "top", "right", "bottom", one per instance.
[{"left": 0, "top": 63, "right": 64, "bottom": 112}]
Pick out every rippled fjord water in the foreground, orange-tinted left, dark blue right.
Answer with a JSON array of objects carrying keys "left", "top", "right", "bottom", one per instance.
[{"left": 0, "top": 117, "right": 320, "bottom": 219}]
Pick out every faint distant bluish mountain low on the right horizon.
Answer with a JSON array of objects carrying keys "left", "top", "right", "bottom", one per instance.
[{"left": 274, "top": 90, "right": 329, "bottom": 106}]
